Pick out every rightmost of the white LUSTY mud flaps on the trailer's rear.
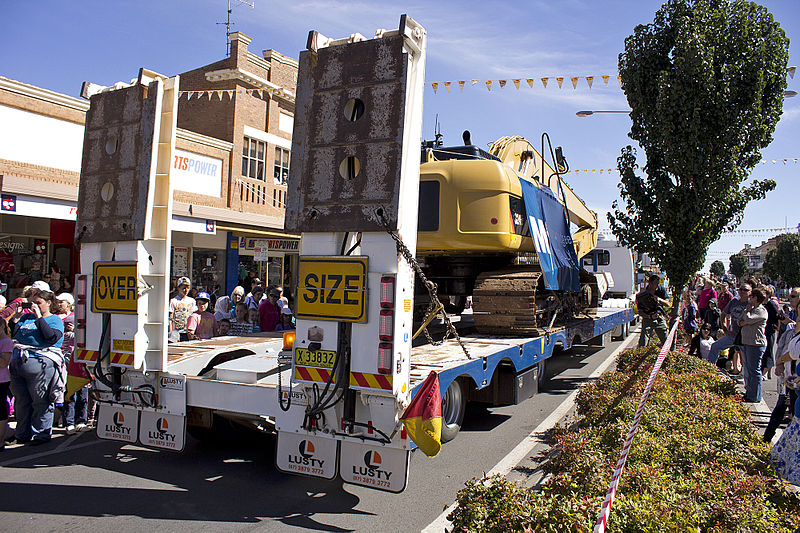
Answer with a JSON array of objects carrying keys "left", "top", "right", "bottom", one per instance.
[{"left": 339, "top": 442, "right": 411, "bottom": 492}]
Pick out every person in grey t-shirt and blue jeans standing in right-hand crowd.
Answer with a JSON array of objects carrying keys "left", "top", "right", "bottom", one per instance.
[{"left": 739, "top": 289, "right": 767, "bottom": 403}]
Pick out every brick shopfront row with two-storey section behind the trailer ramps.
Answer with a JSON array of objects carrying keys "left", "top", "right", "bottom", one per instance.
[{"left": 0, "top": 33, "right": 298, "bottom": 297}]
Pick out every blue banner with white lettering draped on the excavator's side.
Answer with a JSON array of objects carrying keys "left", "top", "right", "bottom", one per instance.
[{"left": 520, "top": 180, "right": 580, "bottom": 291}]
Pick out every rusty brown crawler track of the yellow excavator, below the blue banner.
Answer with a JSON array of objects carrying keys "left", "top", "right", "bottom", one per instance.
[{"left": 472, "top": 266, "right": 557, "bottom": 336}]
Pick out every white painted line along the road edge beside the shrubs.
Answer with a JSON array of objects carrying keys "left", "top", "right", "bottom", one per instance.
[{"left": 422, "top": 329, "right": 639, "bottom": 533}]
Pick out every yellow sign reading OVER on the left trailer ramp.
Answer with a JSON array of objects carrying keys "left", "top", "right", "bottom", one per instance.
[{"left": 92, "top": 261, "right": 139, "bottom": 315}]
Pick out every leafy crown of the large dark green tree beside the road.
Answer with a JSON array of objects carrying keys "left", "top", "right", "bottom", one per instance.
[{"left": 608, "top": 0, "right": 789, "bottom": 304}]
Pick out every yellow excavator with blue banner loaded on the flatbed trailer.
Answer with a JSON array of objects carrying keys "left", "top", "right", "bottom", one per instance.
[{"left": 415, "top": 132, "right": 600, "bottom": 335}]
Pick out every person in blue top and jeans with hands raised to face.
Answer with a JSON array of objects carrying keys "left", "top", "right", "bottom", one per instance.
[{"left": 9, "top": 289, "right": 66, "bottom": 444}]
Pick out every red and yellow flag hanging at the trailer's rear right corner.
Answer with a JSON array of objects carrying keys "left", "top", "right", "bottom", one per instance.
[{"left": 400, "top": 372, "right": 442, "bottom": 457}]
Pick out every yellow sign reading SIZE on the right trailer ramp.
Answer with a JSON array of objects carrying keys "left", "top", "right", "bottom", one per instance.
[{"left": 296, "top": 256, "right": 367, "bottom": 322}]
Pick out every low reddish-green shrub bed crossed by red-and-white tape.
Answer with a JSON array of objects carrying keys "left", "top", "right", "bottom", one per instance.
[{"left": 449, "top": 347, "right": 800, "bottom": 532}]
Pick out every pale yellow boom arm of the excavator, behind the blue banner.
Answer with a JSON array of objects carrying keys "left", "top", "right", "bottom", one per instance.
[{"left": 489, "top": 137, "right": 598, "bottom": 259}]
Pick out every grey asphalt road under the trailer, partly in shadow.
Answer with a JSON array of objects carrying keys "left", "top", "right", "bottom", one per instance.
[{"left": 0, "top": 330, "right": 633, "bottom": 533}]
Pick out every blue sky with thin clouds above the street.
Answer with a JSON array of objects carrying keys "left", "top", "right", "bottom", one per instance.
[{"left": 0, "top": 0, "right": 800, "bottom": 268}]
